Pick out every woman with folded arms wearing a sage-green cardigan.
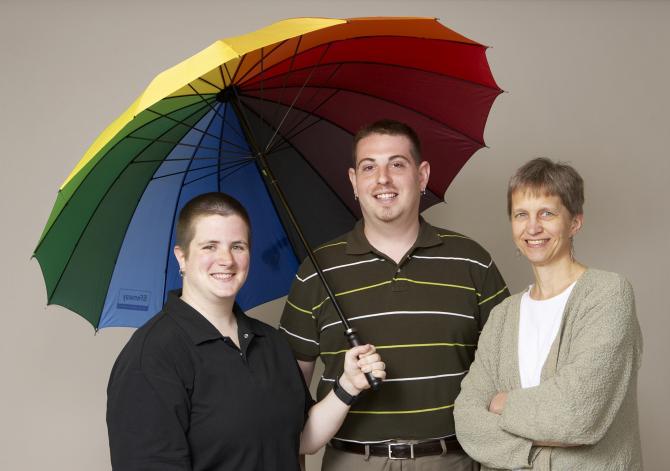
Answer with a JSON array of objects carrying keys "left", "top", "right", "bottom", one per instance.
[{"left": 454, "top": 158, "right": 642, "bottom": 471}]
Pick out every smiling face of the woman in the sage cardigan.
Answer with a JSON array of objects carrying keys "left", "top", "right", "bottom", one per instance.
[{"left": 511, "top": 188, "right": 583, "bottom": 267}]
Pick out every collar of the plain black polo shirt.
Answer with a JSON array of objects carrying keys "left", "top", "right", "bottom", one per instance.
[{"left": 165, "top": 290, "right": 264, "bottom": 345}]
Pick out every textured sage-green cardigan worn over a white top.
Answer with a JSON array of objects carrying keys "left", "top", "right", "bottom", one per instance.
[{"left": 454, "top": 269, "right": 642, "bottom": 471}]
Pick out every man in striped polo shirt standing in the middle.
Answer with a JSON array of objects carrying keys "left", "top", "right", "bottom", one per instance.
[{"left": 280, "top": 120, "right": 509, "bottom": 471}]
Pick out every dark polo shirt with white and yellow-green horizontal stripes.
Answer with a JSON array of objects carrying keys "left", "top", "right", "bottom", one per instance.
[{"left": 279, "top": 219, "right": 509, "bottom": 442}]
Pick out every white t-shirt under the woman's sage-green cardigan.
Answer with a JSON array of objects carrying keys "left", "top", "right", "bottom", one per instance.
[{"left": 519, "top": 282, "right": 576, "bottom": 388}]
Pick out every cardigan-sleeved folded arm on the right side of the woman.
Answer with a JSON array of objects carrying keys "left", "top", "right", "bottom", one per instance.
[{"left": 500, "top": 279, "right": 639, "bottom": 445}]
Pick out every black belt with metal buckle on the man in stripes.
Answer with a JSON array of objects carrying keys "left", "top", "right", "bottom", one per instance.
[{"left": 330, "top": 438, "right": 463, "bottom": 460}]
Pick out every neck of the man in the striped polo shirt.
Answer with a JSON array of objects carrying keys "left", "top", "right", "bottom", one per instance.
[{"left": 363, "top": 216, "right": 420, "bottom": 263}]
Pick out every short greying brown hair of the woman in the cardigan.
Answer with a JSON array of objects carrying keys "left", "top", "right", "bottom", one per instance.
[{"left": 507, "top": 157, "right": 584, "bottom": 217}]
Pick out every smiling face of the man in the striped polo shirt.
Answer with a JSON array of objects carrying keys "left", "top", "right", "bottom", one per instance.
[{"left": 349, "top": 134, "right": 430, "bottom": 229}]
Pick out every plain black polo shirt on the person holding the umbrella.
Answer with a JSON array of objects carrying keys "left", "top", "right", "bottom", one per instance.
[{"left": 107, "top": 292, "right": 312, "bottom": 471}]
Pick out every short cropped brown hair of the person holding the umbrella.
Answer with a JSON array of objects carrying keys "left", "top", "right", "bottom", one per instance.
[{"left": 175, "top": 192, "right": 251, "bottom": 254}]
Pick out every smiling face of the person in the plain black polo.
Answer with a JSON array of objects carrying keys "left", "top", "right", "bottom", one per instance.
[{"left": 174, "top": 214, "right": 250, "bottom": 305}]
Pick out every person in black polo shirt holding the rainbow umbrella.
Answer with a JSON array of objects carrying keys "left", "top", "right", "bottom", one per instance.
[{"left": 107, "top": 193, "right": 385, "bottom": 471}]
